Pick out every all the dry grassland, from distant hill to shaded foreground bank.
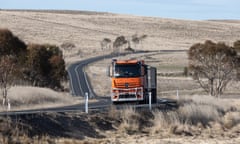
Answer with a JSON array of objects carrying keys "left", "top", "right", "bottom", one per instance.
[{"left": 0, "top": 10, "right": 240, "bottom": 144}]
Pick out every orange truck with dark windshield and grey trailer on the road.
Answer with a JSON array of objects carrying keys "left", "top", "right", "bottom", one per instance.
[{"left": 108, "top": 59, "right": 157, "bottom": 103}]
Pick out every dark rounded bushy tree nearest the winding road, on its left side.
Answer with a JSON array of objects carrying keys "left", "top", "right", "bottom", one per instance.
[{"left": 25, "top": 44, "right": 66, "bottom": 89}]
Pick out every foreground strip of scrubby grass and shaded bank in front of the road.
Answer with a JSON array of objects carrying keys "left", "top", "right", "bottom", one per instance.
[{"left": 0, "top": 96, "right": 240, "bottom": 143}]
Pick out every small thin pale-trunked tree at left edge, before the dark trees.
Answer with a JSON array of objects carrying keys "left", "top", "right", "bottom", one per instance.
[{"left": 0, "top": 56, "right": 14, "bottom": 105}]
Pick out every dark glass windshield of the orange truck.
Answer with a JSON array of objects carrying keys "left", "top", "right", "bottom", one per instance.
[{"left": 114, "top": 64, "right": 141, "bottom": 77}]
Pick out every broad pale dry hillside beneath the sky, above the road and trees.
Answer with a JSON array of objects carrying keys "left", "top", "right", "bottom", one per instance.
[{"left": 0, "top": 10, "right": 240, "bottom": 62}]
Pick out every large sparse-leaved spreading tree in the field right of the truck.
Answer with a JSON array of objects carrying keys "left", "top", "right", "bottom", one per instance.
[{"left": 188, "top": 41, "right": 237, "bottom": 97}]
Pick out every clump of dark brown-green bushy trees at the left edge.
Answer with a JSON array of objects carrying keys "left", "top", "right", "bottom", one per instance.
[{"left": 0, "top": 29, "right": 66, "bottom": 93}]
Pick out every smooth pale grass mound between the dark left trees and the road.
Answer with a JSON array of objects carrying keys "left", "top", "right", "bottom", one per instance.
[{"left": 0, "top": 86, "right": 81, "bottom": 110}]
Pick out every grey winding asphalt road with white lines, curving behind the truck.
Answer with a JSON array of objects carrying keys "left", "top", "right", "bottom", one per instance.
[{"left": 0, "top": 51, "right": 180, "bottom": 115}]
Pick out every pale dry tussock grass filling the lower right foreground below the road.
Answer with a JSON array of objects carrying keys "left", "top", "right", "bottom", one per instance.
[{"left": 105, "top": 95, "right": 240, "bottom": 144}]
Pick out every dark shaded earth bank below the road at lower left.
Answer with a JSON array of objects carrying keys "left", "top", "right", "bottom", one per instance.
[{"left": 1, "top": 113, "right": 113, "bottom": 139}]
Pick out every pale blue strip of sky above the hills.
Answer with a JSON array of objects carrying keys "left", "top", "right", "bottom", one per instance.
[{"left": 0, "top": 0, "right": 240, "bottom": 20}]
